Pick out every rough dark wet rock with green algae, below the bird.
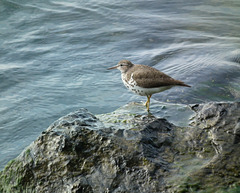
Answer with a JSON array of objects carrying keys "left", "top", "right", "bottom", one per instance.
[{"left": 0, "top": 102, "right": 240, "bottom": 193}]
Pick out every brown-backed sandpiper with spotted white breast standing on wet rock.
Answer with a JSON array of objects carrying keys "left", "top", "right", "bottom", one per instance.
[{"left": 108, "top": 60, "right": 190, "bottom": 111}]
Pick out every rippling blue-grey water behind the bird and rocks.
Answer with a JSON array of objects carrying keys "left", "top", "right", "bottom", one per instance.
[{"left": 0, "top": 0, "right": 240, "bottom": 168}]
